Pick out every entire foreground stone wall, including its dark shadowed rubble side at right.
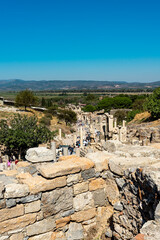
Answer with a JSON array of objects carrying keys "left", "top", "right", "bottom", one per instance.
[{"left": 0, "top": 152, "right": 160, "bottom": 240}]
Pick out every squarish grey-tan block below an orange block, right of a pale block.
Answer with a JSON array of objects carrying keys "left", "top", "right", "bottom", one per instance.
[{"left": 92, "top": 189, "right": 107, "bottom": 206}]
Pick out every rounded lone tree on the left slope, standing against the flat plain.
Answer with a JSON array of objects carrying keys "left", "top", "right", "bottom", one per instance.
[{"left": 15, "top": 89, "right": 37, "bottom": 111}]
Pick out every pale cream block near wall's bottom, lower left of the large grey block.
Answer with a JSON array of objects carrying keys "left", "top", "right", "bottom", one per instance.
[{"left": 26, "top": 218, "right": 56, "bottom": 236}]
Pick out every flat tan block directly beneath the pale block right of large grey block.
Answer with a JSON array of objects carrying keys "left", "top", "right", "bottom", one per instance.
[{"left": 71, "top": 208, "right": 96, "bottom": 222}]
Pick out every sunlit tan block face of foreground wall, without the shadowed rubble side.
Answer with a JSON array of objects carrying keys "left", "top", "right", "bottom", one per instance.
[{"left": 0, "top": 156, "right": 116, "bottom": 240}]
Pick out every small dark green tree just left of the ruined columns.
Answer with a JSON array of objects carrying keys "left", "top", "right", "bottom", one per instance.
[{"left": 57, "top": 110, "right": 77, "bottom": 126}]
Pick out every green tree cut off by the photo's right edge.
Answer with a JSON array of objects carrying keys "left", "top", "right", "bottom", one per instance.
[{"left": 144, "top": 88, "right": 160, "bottom": 119}]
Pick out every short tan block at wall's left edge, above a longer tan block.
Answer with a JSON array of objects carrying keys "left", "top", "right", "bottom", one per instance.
[{"left": 0, "top": 204, "right": 24, "bottom": 222}]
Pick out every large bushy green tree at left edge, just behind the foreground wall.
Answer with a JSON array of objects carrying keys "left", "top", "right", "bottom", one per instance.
[{"left": 0, "top": 114, "right": 53, "bottom": 158}]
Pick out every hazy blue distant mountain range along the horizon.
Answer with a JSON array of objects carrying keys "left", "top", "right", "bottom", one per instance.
[{"left": 0, "top": 79, "right": 160, "bottom": 91}]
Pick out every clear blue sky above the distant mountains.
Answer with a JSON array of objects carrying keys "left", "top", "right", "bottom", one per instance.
[{"left": 0, "top": 0, "right": 160, "bottom": 82}]
